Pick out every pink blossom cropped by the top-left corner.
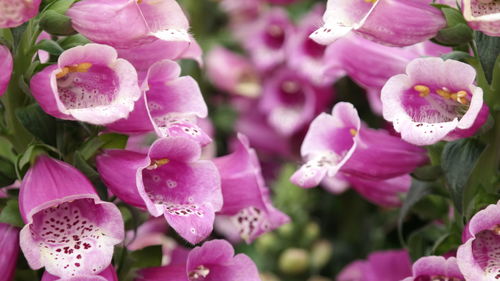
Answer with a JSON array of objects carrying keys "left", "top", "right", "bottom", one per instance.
[{"left": 0, "top": 0, "right": 42, "bottom": 28}]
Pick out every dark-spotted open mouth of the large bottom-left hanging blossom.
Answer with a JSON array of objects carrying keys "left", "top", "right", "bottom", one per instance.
[{"left": 30, "top": 199, "right": 117, "bottom": 276}]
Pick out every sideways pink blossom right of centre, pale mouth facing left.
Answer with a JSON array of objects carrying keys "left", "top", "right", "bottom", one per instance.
[{"left": 291, "top": 102, "right": 428, "bottom": 188}]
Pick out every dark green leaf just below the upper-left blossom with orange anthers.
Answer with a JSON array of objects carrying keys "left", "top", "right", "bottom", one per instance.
[{"left": 16, "top": 104, "right": 56, "bottom": 146}]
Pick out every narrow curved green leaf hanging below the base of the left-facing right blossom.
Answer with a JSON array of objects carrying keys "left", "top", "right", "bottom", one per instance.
[{"left": 398, "top": 179, "right": 432, "bottom": 244}]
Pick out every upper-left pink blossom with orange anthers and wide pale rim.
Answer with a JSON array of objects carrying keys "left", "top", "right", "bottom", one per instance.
[{"left": 30, "top": 44, "right": 141, "bottom": 125}]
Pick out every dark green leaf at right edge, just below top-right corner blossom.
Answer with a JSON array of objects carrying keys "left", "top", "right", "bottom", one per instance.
[{"left": 475, "top": 31, "right": 500, "bottom": 82}]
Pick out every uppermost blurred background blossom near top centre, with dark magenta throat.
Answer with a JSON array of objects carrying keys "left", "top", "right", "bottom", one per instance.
[{"left": 236, "top": 8, "right": 293, "bottom": 71}]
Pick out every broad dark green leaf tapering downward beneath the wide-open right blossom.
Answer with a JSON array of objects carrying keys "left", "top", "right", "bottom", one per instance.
[{"left": 441, "top": 139, "right": 485, "bottom": 214}]
